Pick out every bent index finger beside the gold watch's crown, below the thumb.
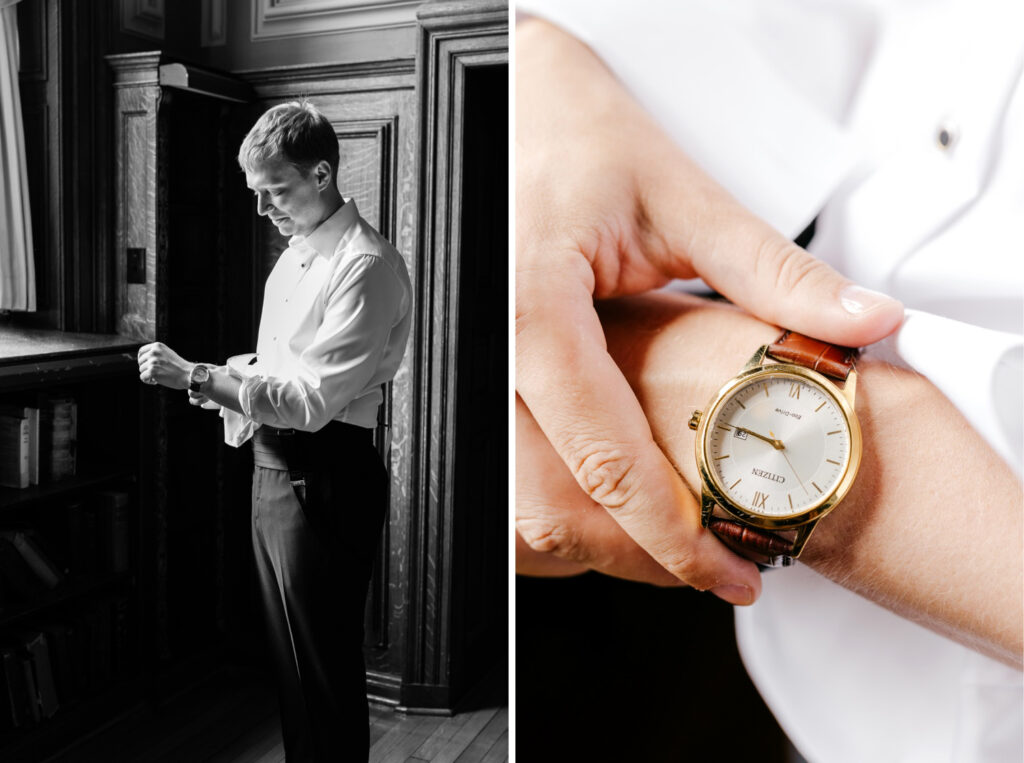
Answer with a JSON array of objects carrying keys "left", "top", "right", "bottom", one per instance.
[{"left": 516, "top": 262, "right": 760, "bottom": 603}]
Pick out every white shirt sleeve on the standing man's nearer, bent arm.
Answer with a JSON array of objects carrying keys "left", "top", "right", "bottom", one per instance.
[{"left": 239, "top": 254, "right": 403, "bottom": 431}]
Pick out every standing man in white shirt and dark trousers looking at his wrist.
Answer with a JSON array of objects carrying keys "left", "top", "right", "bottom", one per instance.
[{"left": 138, "top": 102, "right": 412, "bottom": 762}]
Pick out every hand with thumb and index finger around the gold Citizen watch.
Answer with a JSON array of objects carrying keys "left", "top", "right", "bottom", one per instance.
[{"left": 516, "top": 19, "right": 902, "bottom": 603}]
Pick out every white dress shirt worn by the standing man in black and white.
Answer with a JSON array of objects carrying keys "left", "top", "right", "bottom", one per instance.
[{"left": 221, "top": 200, "right": 413, "bottom": 447}]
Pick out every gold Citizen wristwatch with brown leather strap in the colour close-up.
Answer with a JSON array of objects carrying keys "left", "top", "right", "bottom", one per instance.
[{"left": 689, "top": 331, "right": 862, "bottom": 567}]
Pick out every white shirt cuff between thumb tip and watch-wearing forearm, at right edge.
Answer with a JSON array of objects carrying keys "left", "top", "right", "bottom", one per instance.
[{"left": 865, "top": 310, "right": 1024, "bottom": 477}]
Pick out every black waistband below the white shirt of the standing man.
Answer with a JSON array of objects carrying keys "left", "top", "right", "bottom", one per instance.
[{"left": 253, "top": 421, "right": 374, "bottom": 488}]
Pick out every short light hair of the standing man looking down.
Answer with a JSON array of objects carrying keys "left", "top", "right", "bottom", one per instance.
[{"left": 239, "top": 100, "right": 339, "bottom": 182}]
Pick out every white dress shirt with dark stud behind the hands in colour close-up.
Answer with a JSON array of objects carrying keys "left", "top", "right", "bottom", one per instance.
[{"left": 518, "top": 0, "right": 1024, "bottom": 763}]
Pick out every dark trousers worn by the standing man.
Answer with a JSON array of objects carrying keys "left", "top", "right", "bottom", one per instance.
[{"left": 252, "top": 427, "right": 387, "bottom": 763}]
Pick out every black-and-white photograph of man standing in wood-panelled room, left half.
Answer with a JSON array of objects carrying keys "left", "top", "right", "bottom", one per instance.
[{"left": 0, "top": 0, "right": 510, "bottom": 763}]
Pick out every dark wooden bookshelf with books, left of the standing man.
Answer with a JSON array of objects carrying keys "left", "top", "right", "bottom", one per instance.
[{"left": 0, "top": 326, "right": 148, "bottom": 761}]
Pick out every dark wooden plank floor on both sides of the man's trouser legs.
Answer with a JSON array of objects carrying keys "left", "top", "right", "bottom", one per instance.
[{"left": 47, "top": 670, "right": 509, "bottom": 763}]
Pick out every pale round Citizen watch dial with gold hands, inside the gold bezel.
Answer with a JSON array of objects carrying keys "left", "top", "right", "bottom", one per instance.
[{"left": 705, "top": 372, "right": 851, "bottom": 517}]
